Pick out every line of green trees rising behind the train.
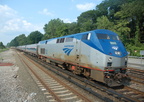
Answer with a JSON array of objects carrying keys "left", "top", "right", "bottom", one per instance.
[{"left": 8, "top": 0, "right": 144, "bottom": 55}]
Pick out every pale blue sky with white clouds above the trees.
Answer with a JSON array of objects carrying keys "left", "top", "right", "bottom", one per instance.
[{"left": 0, "top": 0, "right": 103, "bottom": 45}]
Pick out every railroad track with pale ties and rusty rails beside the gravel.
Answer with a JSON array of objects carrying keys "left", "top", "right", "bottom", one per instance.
[{"left": 16, "top": 51, "right": 91, "bottom": 102}]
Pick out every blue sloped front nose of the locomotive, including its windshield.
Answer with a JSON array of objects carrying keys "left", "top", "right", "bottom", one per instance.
[{"left": 96, "top": 30, "right": 127, "bottom": 57}]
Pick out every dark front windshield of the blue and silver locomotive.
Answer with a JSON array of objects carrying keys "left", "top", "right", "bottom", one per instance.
[{"left": 97, "top": 34, "right": 119, "bottom": 40}]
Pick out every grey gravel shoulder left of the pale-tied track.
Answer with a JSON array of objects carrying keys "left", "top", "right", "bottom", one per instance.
[{"left": 0, "top": 49, "right": 47, "bottom": 102}]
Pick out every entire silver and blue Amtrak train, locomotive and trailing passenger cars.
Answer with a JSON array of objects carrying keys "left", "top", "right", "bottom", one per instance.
[{"left": 17, "top": 29, "right": 129, "bottom": 87}]
